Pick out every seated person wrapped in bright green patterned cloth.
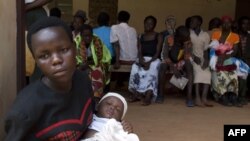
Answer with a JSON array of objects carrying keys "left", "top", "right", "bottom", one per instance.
[{"left": 76, "top": 24, "right": 111, "bottom": 100}]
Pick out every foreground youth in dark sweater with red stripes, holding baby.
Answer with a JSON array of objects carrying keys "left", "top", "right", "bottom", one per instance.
[{"left": 5, "top": 17, "right": 93, "bottom": 141}]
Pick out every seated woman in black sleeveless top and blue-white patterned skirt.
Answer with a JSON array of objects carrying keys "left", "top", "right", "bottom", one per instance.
[{"left": 128, "top": 16, "right": 162, "bottom": 106}]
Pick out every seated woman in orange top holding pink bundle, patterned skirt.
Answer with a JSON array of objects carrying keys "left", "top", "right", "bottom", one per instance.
[{"left": 210, "top": 16, "right": 240, "bottom": 106}]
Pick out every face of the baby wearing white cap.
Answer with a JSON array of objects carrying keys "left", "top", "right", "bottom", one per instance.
[{"left": 97, "top": 96, "right": 124, "bottom": 121}]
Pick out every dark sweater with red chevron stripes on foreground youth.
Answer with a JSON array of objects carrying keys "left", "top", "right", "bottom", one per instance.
[{"left": 5, "top": 71, "right": 93, "bottom": 141}]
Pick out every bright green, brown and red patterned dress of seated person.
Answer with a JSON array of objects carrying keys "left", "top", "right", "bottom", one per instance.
[{"left": 75, "top": 35, "right": 111, "bottom": 98}]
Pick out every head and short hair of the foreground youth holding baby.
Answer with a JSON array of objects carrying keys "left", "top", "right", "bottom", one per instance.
[{"left": 27, "top": 17, "right": 76, "bottom": 84}]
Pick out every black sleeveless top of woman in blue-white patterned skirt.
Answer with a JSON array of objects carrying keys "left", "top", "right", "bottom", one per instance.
[{"left": 140, "top": 34, "right": 158, "bottom": 57}]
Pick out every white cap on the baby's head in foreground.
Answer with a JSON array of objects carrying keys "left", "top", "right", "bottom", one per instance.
[{"left": 99, "top": 92, "right": 128, "bottom": 119}]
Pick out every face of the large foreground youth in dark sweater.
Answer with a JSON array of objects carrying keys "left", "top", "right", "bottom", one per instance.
[{"left": 31, "top": 27, "right": 76, "bottom": 84}]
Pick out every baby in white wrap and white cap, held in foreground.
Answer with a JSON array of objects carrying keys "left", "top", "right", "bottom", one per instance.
[{"left": 84, "top": 92, "right": 139, "bottom": 141}]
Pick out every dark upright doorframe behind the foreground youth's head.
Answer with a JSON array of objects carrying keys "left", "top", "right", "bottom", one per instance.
[{"left": 16, "top": 0, "right": 26, "bottom": 93}]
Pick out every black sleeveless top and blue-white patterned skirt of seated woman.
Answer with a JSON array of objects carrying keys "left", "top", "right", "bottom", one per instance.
[{"left": 128, "top": 34, "right": 160, "bottom": 97}]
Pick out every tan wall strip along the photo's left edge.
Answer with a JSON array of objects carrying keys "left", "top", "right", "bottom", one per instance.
[{"left": 0, "top": 0, "right": 16, "bottom": 141}]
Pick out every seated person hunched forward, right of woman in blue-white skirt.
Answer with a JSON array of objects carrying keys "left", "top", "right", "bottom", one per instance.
[{"left": 156, "top": 26, "right": 194, "bottom": 107}]
